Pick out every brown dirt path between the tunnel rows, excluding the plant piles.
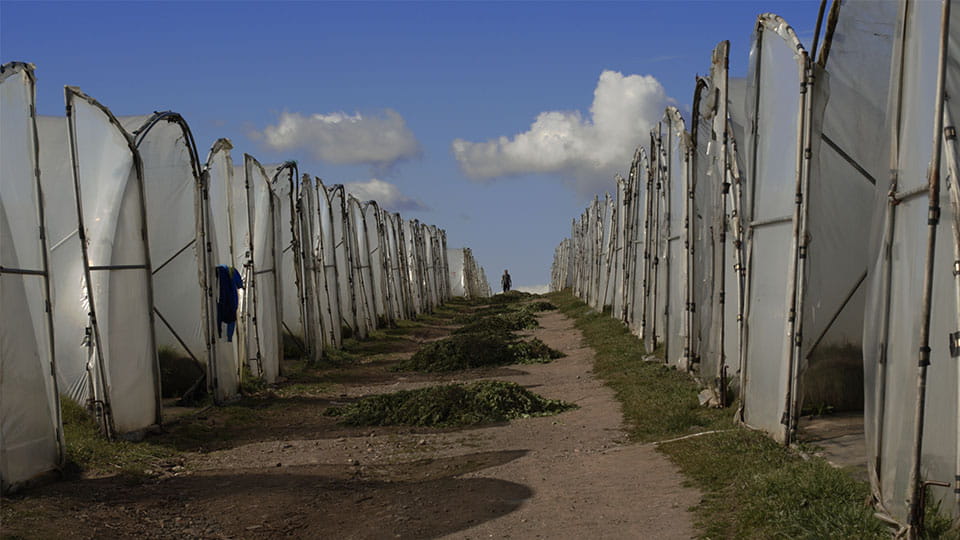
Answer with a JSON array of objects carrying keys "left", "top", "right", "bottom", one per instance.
[{"left": 0, "top": 296, "right": 700, "bottom": 538}]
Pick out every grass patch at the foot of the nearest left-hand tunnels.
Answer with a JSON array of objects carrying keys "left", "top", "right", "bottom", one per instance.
[{"left": 60, "top": 396, "right": 176, "bottom": 477}]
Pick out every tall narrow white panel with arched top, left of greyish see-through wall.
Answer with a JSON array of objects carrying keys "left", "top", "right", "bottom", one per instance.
[{"left": 741, "top": 14, "right": 809, "bottom": 441}]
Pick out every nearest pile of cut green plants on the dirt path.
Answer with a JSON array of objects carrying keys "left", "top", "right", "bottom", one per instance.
[{"left": 325, "top": 381, "right": 576, "bottom": 427}]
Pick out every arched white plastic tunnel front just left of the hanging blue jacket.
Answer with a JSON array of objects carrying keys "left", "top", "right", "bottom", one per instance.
[{"left": 118, "top": 112, "right": 219, "bottom": 404}]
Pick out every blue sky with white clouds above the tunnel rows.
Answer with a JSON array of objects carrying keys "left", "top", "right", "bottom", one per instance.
[{"left": 0, "top": 0, "right": 819, "bottom": 294}]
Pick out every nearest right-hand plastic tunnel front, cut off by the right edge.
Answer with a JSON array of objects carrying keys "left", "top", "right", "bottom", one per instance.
[{"left": 864, "top": 2, "right": 960, "bottom": 533}]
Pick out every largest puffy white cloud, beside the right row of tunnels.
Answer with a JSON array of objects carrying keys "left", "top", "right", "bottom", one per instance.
[{"left": 453, "top": 70, "right": 670, "bottom": 193}]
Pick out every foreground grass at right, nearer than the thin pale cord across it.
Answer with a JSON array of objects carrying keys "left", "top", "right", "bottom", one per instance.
[{"left": 659, "top": 428, "right": 890, "bottom": 539}]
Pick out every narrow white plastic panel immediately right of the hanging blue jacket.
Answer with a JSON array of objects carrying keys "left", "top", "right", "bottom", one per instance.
[{"left": 243, "top": 154, "right": 283, "bottom": 383}]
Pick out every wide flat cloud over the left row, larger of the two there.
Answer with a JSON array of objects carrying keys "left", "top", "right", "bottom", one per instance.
[{"left": 252, "top": 109, "right": 420, "bottom": 167}]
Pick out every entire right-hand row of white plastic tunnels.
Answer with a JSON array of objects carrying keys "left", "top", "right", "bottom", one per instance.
[{"left": 552, "top": 0, "right": 960, "bottom": 534}]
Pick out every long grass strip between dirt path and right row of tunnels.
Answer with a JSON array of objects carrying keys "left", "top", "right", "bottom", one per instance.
[{"left": 547, "top": 291, "right": 890, "bottom": 539}]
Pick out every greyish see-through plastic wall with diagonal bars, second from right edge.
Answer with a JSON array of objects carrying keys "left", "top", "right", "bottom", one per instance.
[{"left": 791, "top": 2, "right": 897, "bottom": 422}]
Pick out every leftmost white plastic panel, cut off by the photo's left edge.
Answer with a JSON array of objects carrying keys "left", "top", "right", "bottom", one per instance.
[{"left": 0, "top": 63, "right": 63, "bottom": 493}]
